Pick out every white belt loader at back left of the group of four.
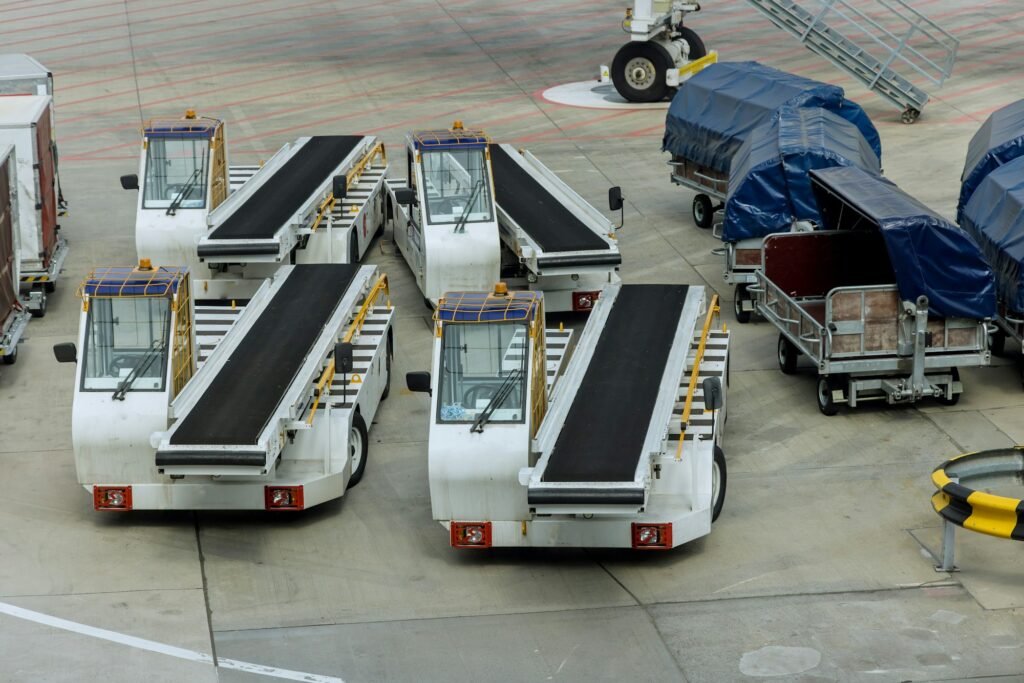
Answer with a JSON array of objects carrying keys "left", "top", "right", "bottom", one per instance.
[{"left": 121, "top": 110, "right": 387, "bottom": 298}]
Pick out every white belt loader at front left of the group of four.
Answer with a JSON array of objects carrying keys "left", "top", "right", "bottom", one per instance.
[{"left": 54, "top": 261, "right": 394, "bottom": 511}]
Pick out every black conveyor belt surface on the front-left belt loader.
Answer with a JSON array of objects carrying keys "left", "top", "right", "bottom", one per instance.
[{"left": 170, "top": 263, "right": 359, "bottom": 448}]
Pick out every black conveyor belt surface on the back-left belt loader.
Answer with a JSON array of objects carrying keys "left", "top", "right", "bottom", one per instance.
[{"left": 210, "top": 135, "right": 362, "bottom": 240}]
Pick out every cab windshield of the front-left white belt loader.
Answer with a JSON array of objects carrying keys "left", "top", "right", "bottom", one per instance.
[{"left": 82, "top": 297, "right": 171, "bottom": 391}]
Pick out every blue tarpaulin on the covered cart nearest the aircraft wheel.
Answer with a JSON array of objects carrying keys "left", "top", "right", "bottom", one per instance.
[{"left": 662, "top": 61, "right": 882, "bottom": 173}]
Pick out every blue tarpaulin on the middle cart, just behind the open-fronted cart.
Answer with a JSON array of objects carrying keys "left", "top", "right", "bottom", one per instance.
[{"left": 722, "top": 105, "right": 882, "bottom": 242}]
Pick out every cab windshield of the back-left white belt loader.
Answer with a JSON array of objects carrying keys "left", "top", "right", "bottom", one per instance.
[{"left": 142, "top": 137, "right": 210, "bottom": 209}]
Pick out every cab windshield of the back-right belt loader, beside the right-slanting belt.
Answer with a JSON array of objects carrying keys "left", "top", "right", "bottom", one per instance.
[{"left": 423, "top": 150, "right": 495, "bottom": 224}]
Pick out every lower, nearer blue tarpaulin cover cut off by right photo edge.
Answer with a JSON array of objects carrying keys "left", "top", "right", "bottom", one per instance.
[{"left": 961, "top": 157, "right": 1024, "bottom": 312}]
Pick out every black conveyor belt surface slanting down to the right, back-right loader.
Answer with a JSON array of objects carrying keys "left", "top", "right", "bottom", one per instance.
[{"left": 490, "top": 144, "right": 608, "bottom": 252}]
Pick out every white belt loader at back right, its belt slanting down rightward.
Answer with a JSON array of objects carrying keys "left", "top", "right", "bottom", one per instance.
[{"left": 387, "top": 121, "right": 622, "bottom": 311}]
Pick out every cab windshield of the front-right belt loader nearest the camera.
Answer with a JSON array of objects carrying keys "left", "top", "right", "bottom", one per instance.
[{"left": 437, "top": 323, "right": 528, "bottom": 423}]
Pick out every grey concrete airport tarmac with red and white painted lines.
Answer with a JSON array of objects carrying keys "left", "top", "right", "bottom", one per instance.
[{"left": 0, "top": 0, "right": 1024, "bottom": 683}]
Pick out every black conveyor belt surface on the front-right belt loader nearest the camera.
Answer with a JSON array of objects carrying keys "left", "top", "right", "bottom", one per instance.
[{"left": 543, "top": 285, "right": 689, "bottom": 482}]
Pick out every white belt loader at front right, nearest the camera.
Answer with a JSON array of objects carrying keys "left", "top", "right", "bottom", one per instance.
[{"left": 407, "top": 284, "right": 729, "bottom": 549}]
